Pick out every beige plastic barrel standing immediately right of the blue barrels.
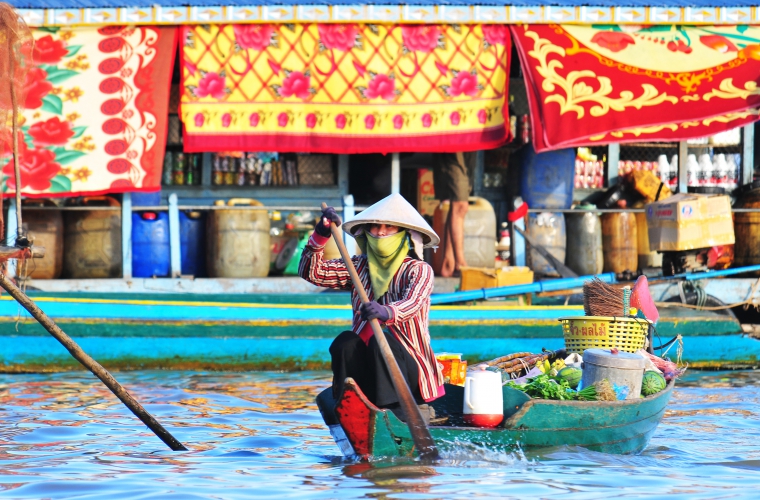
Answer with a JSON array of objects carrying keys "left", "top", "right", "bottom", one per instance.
[{"left": 206, "top": 198, "right": 271, "bottom": 278}]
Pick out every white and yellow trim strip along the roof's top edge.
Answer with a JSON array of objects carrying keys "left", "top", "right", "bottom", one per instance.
[{"left": 10, "top": 0, "right": 760, "bottom": 26}]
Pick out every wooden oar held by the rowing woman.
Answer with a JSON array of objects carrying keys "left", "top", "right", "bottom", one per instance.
[{"left": 322, "top": 203, "right": 439, "bottom": 460}]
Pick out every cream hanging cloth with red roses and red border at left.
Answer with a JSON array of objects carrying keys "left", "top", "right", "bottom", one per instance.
[{"left": 0, "top": 26, "right": 177, "bottom": 197}]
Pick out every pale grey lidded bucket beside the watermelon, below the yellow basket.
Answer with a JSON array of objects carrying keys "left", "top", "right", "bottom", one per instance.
[{"left": 581, "top": 349, "right": 646, "bottom": 399}]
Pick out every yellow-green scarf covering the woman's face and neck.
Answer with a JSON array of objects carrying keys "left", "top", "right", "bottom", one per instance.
[{"left": 356, "top": 230, "right": 409, "bottom": 300}]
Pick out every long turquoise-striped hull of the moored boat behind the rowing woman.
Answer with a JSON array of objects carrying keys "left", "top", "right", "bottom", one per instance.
[{"left": 0, "top": 292, "right": 760, "bottom": 372}]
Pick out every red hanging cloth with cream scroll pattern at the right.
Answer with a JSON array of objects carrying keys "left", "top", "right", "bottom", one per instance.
[{"left": 510, "top": 25, "right": 760, "bottom": 151}]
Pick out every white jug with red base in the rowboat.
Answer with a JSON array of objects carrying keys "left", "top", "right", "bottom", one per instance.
[{"left": 462, "top": 365, "right": 504, "bottom": 427}]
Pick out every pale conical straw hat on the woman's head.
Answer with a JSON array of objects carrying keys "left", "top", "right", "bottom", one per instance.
[{"left": 343, "top": 194, "right": 441, "bottom": 248}]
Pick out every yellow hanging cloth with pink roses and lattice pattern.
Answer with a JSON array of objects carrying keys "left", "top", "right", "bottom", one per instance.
[{"left": 180, "top": 24, "right": 511, "bottom": 153}]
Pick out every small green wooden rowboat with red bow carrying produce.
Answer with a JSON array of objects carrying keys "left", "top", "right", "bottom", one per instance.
[{"left": 317, "top": 379, "right": 674, "bottom": 459}]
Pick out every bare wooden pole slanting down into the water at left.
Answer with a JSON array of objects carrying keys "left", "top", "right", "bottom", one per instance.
[{"left": 0, "top": 273, "right": 187, "bottom": 451}]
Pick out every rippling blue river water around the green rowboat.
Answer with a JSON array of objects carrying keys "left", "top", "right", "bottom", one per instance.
[{"left": 0, "top": 371, "right": 760, "bottom": 499}]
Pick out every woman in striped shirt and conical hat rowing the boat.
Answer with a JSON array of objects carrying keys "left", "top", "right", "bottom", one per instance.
[{"left": 299, "top": 194, "right": 444, "bottom": 419}]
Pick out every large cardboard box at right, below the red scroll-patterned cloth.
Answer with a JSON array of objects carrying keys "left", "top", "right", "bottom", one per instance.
[{"left": 646, "top": 193, "right": 734, "bottom": 252}]
